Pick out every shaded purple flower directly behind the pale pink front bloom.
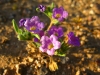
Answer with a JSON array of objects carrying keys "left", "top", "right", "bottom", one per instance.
[{"left": 48, "top": 26, "right": 63, "bottom": 38}]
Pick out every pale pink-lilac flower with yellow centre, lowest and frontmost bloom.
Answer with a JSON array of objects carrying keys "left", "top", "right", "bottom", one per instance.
[{"left": 39, "top": 35, "right": 61, "bottom": 56}]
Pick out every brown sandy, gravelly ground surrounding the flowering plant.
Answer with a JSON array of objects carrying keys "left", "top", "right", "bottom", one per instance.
[{"left": 0, "top": 0, "right": 100, "bottom": 75}]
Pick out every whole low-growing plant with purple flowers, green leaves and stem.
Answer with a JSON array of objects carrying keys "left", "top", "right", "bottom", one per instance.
[{"left": 12, "top": 3, "right": 80, "bottom": 71}]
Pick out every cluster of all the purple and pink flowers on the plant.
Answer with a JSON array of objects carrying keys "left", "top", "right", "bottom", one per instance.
[{"left": 19, "top": 5, "right": 80, "bottom": 56}]
